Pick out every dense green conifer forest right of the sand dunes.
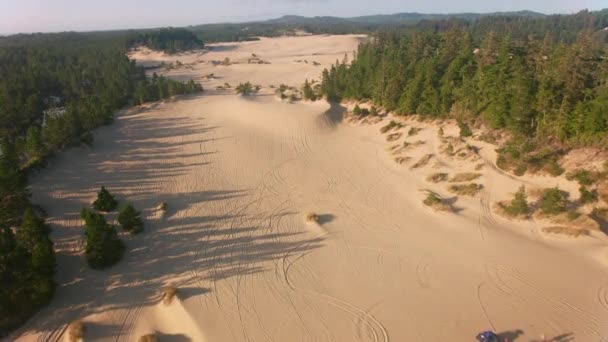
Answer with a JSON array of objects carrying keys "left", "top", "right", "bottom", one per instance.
[{"left": 321, "top": 10, "right": 608, "bottom": 173}]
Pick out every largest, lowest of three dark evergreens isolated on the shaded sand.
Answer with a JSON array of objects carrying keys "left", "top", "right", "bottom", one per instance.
[{"left": 80, "top": 208, "right": 125, "bottom": 269}]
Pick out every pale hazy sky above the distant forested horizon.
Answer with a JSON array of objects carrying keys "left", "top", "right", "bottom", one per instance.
[{"left": 0, "top": 0, "right": 608, "bottom": 34}]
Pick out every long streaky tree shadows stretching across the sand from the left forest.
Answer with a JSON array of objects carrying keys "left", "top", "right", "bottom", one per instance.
[{"left": 13, "top": 101, "right": 323, "bottom": 340}]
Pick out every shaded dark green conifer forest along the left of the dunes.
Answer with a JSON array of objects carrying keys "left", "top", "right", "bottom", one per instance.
[{"left": 0, "top": 33, "right": 202, "bottom": 336}]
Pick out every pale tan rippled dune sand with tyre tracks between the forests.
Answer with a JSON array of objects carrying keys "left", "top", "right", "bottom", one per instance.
[{"left": 11, "top": 36, "right": 608, "bottom": 341}]
